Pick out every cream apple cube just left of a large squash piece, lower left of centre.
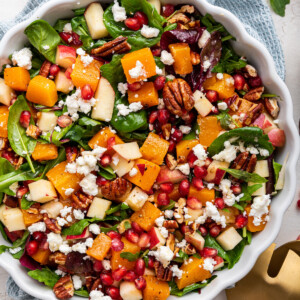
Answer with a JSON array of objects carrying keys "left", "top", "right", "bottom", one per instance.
[{"left": 28, "top": 179, "right": 57, "bottom": 203}]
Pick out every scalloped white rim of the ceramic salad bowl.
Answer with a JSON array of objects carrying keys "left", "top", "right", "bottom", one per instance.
[{"left": 0, "top": 0, "right": 300, "bottom": 300}]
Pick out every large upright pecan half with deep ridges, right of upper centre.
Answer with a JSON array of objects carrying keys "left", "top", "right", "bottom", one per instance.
[{"left": 163, "top": 78, "right": 195, "bottom": 117}]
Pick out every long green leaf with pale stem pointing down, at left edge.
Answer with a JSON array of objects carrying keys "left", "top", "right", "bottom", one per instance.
[{"left": 7, "top": 95, "right": 36, "bottom": 172}]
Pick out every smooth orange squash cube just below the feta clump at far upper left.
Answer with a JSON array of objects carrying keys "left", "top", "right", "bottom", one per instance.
[{"left": 4, "top": 67, "right": 30, "bottom": 92}]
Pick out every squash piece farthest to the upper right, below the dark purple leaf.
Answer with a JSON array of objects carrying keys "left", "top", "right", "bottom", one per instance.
[{"left": 203, "top": 73, "right": 235, "bottom": 99}]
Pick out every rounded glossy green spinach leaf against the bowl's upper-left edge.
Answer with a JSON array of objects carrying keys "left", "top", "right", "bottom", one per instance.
[{"left": 24, "top": 20, "right": 60, "bottom": 63}]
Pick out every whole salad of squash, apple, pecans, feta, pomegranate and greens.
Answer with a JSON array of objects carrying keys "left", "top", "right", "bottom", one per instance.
[{"left": 0, "top": 0, "right": 285, "bottom": 300}]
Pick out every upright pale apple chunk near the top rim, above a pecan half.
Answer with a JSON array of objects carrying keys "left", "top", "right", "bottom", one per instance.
[{"left": 84, "top": 2, "right": 108, "bottom": 39}]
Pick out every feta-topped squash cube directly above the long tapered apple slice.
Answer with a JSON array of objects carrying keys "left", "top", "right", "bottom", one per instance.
[{"left": 71, "top": 56, "right": 103, "bottom": 92}]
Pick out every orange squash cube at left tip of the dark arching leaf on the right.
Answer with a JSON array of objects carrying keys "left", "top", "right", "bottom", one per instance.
[{"left": 198, "top": 116, "right": 224, "bottom": 147}]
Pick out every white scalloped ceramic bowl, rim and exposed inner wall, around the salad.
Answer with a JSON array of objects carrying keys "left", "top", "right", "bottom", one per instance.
[{"left": 0, "top": 0, "right": 299, "bottom": 300}]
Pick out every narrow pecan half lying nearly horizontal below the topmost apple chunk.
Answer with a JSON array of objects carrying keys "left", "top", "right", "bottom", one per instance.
[{"left": 91, "top": 36, "right": 131, "bottom": 57}]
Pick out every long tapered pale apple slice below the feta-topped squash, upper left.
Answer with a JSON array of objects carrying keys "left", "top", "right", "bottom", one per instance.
[{"left": 92, "top": 77, "right": 115, "bottom": 122}]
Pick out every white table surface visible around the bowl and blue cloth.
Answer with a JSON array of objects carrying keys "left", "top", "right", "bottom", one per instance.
[{"left": 0, "top": 0, "right": 300, "bottom": 300}]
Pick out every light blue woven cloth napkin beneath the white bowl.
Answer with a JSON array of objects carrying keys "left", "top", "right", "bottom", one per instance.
[{"left": 0, "top": 0, "right": 285, "bottom": 300}]
